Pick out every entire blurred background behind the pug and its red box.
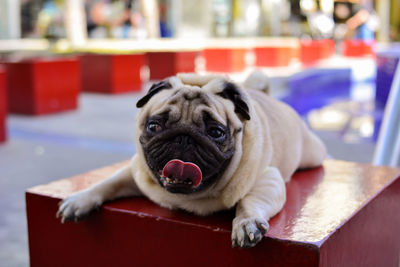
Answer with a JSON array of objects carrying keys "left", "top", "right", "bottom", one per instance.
[{"left": 0, "top": 0, "right": 400, "bottom": 266}]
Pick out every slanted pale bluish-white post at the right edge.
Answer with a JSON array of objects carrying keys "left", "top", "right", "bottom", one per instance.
[{"left": 373, "top": 61, "right": 400, "bottom": 166}]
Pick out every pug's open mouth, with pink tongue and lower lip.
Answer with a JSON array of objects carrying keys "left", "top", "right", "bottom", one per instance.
[{"left": 159, "top": 159, "right": 202, "bottom": 192}]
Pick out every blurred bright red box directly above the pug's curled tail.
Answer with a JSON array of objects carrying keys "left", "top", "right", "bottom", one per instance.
[{"left": 254, "top": 46, "right": 295, "bottom": 67}]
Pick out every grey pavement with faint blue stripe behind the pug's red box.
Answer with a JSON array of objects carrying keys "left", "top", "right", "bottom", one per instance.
[{"left": 0, "top": 87, "right": 374, "bottom": 267}]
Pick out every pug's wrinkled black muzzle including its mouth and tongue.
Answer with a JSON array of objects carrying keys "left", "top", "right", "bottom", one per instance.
[{"left": 141, "top": 126, "right": 234, "bottom": 194}]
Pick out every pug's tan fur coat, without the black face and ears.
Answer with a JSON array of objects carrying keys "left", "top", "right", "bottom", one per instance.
[{"left": 59, "top": 74, "right": 326, "bottom": 247}]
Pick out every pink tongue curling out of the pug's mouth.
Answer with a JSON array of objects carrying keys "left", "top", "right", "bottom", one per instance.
[{"left": 163, "top": 159, "right": 202, "bottom": 187}]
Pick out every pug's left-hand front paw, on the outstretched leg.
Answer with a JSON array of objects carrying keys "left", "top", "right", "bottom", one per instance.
[{"left": 56, "top": 190, "right": 102, "bottom": 223}]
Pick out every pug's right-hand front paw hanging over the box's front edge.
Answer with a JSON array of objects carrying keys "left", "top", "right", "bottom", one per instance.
[{"left": 232, "top": 217, "right": 269, "bottom": 248}]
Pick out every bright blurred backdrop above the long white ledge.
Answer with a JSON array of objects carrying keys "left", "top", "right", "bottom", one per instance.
[{"left": 0, "top": 0, "right": 400, "bottom": 42}]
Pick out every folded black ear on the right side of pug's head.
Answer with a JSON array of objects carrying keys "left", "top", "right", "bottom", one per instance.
[{"left": 217, "top": 82, "right": 250, "bottom": 120}]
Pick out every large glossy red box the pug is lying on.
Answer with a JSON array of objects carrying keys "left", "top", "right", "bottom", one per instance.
[{"left": 26, "top": 160, "right": 400, "bottom": 267}]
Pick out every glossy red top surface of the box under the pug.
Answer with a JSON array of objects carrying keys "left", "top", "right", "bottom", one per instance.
[{"left": 28, "top": 160, "right": 400, "bottom": 245}]
